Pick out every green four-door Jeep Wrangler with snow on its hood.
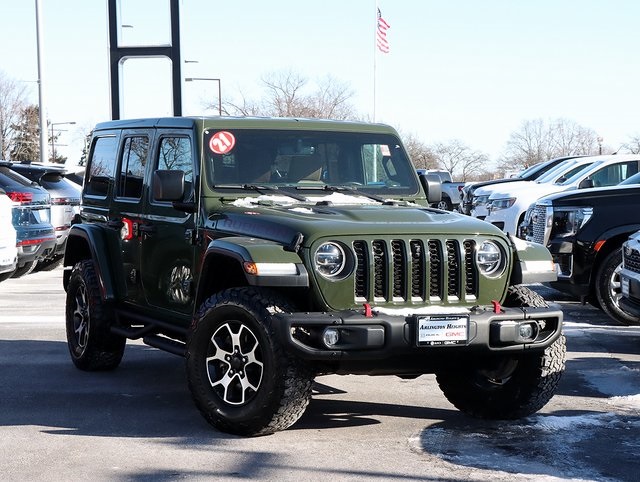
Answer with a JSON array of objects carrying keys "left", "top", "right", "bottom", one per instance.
[{"left": 64, "top": 117, "right": 566, "bottom": 435}]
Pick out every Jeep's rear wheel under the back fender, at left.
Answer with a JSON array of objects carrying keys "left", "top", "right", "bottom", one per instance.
[{"left": 65, "top": 260, "right": 127, "bottom": 371}]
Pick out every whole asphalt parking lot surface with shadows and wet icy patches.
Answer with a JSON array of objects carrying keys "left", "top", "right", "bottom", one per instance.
[{"left": 0, "top": 269, "right": 640, "bottom": 481}]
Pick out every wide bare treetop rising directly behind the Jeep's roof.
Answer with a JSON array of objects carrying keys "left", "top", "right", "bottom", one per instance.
[{"left": 223, "top": 71, "right": 357, "bottom": 120}]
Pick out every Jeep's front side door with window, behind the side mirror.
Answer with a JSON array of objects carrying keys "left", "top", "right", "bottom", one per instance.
[{"left": 139, "top": 129, "right": 197, "bottom": 321}]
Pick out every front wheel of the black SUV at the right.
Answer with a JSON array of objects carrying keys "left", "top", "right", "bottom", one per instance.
[{"left": 595, "top": 248, "right": 640, "bottom": 325}]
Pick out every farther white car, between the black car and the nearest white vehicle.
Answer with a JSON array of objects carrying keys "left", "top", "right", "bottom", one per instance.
[{"left": 471, "top": 157, "right": 594, "bottom": 219}]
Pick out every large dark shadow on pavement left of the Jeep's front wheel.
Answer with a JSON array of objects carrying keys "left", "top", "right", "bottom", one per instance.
[{"left": 0, "top": 340, "right": 226, "bottom": 437}]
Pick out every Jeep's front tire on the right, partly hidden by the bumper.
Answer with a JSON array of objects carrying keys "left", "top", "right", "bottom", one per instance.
[{"left": 436, "top": 286, "right": 566, "bottom": 420}]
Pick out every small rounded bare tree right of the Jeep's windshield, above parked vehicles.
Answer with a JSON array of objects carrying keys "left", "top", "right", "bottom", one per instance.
[{"left": 431, "top": 139, "right": 489, "bottom": 182}]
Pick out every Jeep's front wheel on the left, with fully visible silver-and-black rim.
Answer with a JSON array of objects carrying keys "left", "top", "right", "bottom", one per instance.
[{"left": 186, "top": 288, "right": 314, "bottom": 436}]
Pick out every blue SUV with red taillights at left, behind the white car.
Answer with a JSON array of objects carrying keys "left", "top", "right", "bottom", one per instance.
[{"left": 0, "top": 161, "right": 56, "bottom": 278}]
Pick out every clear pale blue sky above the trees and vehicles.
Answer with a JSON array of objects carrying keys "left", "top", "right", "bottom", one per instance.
[{"left": 0, "top": 0, "right": 640, "bottom": 163}]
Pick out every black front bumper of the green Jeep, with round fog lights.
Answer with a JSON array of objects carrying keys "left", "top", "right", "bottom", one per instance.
[{"left": 276, "top": 307, "right": 562, "bottom": 370}]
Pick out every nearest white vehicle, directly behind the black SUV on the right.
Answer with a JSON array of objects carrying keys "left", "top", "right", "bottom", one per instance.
[{"left": 485, "top": 154, "right": 640, "bottom": 235}]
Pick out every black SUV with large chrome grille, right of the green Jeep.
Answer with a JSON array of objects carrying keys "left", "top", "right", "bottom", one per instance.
[{"left": 519, "top": 174, "right": 640, "bottom": 324}]
